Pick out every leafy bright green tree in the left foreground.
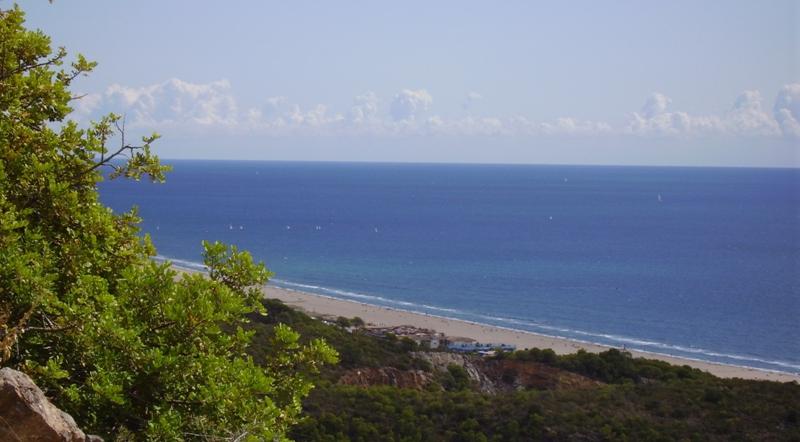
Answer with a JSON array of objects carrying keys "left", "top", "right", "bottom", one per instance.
[{"left": 0, "top": 6, "right": 336, "bottom": 440}]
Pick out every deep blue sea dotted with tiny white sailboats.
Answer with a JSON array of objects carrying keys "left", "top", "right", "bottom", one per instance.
[{"left": 101, "top": 161, "right": 800, "bottom": 373}]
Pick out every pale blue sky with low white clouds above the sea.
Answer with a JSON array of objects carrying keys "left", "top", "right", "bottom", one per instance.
[{"left": 15, "top": 0, "right": 800, "bottom": 167}]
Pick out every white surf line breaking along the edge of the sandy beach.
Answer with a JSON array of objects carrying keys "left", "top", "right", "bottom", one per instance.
[{"left": 156, "top": 255, "right": 800, "bottom": 373}]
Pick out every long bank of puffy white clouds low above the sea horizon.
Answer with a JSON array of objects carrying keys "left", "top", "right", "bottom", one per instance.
[{"left": 73, "top": 78, "right": 800, "bottom": 144}]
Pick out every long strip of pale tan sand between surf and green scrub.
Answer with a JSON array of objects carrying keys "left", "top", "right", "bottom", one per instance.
[{"left": 264, "top": 286, "right": 800, "bottom": 382}]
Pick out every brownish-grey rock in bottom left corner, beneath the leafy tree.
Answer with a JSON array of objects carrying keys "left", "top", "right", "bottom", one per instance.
[{"left": 0, "top": 368, "right": 102, "bottom": 442}]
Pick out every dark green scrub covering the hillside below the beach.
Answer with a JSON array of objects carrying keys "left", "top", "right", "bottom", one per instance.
[{"left": 251, "top": 301, "right": 800, "bottom": 441}]
